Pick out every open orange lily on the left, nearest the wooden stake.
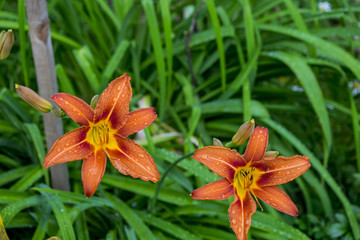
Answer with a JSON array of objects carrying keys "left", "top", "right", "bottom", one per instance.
[{"left": 44, "top": 73, "right": 160, "bottom": 197}]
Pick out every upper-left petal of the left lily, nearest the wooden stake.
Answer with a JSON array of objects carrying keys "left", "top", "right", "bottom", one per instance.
[{"left": 51, "top": 93, "right": 94, "bottom": 126}]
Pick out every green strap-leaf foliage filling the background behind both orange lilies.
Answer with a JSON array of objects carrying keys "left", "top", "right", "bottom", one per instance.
[{"left": 0, "top": 0, "right": 360, "bottom": 240}]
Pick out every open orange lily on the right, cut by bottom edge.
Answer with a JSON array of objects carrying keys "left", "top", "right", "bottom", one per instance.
[{"left": 191, "top": 127, "right": 310, "bottom": 240}]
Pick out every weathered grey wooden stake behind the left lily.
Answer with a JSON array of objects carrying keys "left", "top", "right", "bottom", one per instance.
[{"left": 26, "top": 0, "right": 70, "bottom": 191}]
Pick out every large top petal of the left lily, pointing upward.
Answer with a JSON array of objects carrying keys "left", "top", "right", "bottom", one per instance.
[{"left": 94, "top": 73, "right": 132, "bottom": 129}]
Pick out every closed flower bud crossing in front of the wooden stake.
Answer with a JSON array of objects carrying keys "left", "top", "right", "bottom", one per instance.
[{"left": 15, "top": 84, "right": 52, "bottom": 113}]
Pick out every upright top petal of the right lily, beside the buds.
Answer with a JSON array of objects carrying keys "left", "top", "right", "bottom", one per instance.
[{"left": 244, "top": 127, "right": 269, "bottom": 162}]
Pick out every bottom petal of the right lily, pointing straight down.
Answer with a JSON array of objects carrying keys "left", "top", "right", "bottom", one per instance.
[{"left": 229, "top": 192, "right": 256, "bottom": 240}]
